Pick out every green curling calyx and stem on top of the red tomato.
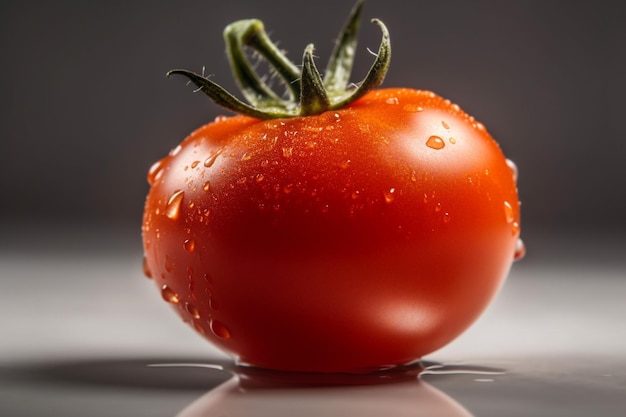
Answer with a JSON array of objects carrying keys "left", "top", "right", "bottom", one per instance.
[{"left": 167, "top": 1, "right": 391, "bottom": 119}]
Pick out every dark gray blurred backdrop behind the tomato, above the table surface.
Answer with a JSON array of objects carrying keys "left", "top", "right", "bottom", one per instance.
[{"left": 0, "top": 0, "right": 626, "bottom": 239}]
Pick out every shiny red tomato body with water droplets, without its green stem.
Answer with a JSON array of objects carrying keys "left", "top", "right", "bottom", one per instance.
[{"left": 143, "top": 89, "right": 520, "bottom": 372}]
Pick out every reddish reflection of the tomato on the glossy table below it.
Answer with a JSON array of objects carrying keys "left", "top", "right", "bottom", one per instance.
[{"left": 177, "top": 372, "right": 471, "bottom": 417}]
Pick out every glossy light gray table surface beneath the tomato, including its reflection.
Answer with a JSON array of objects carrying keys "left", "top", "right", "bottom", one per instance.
[{"left": 0, "top": 232, "right": 626, "bottom": 417}]
